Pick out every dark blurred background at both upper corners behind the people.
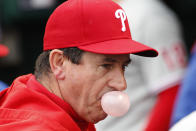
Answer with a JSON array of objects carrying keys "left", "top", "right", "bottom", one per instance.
[{"left": 0, "top": 0, "right": 196, "bottom": 85}]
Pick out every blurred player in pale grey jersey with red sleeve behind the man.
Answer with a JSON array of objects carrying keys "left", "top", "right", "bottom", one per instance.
[{"left": 96, "top": 0, "right": 187, "bottom": 131}]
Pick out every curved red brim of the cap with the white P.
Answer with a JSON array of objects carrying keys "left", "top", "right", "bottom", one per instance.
[{"left": 78, "top": 39, "right": 158, "bottom": 57}]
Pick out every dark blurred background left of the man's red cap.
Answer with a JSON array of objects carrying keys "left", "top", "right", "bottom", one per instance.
[{"left": 0, "top": 0, "right": 62, "bottom": 85}]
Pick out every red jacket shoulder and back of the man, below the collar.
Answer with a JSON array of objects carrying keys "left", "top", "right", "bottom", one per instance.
[{"left": 0, "top": 74, "right": 79, "bottom": 131}]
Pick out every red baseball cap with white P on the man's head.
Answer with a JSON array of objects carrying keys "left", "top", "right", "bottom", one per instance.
[{"left": 43, "top": 0, "right": 158, "bottom": 57}]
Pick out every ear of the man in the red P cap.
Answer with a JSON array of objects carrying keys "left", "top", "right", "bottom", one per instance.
[{"left": 49, "top": 49, "right": 65, "bottom": 80}]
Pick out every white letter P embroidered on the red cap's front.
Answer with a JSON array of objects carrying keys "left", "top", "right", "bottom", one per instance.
[{"left": 115, "top": 9, "right": 126, "bottom": 32}]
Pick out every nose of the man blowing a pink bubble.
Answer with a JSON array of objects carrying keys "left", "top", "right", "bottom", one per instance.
[{"left": 108, "top": 70, "right": 127, "bottom": 91}]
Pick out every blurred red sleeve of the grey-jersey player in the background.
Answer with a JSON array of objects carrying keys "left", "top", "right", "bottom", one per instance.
[{"left": 144, "top": 85, "right": 179, "bottom": 131}]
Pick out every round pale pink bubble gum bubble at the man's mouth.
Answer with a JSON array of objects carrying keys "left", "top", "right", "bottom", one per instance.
[{"left": 101, "top": 91, "right": 130, "bottom": 117}]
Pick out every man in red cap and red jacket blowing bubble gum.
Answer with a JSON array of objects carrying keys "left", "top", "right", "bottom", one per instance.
[{"left": 0, "top": 0, "right": 157, "bottom": 131}]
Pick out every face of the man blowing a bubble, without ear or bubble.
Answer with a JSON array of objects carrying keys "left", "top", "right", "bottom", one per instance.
[{"left": 61, "top": 52, "right": 130, "bottom": 123}]
